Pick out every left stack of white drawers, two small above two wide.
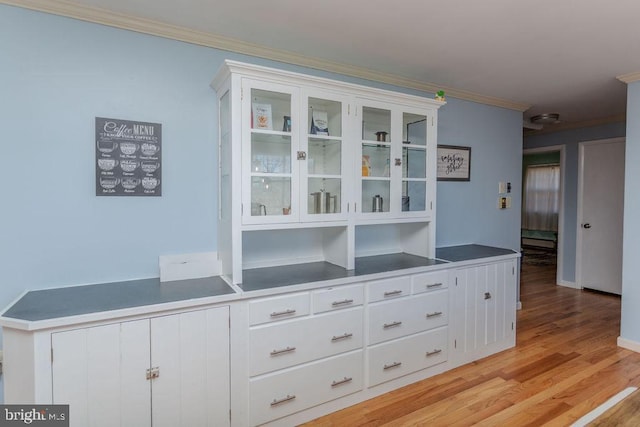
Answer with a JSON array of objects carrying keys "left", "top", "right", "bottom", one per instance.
[{"left": 247, "top": 284, "right": 364, "bottom": 425}]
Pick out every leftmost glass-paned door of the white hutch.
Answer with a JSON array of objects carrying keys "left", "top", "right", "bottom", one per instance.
[{"left": 243, "top": 83, "right": 298, "bottom": 223}]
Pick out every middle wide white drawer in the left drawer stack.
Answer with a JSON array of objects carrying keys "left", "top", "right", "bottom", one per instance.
[{"left": 249, "top": 307, "right": 363, "bottom": 376}]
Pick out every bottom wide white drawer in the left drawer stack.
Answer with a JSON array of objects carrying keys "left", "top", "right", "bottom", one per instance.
[{"left": 249, "top": 350, "right": 364, "bottom": 425}]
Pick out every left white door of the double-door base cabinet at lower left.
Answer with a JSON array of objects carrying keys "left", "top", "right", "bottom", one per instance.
[{"left": 51, "top": 320, "right": 151, "bottom": 427}]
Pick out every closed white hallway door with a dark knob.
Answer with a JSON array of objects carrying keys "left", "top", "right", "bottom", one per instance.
[{"left": 576, "top": 138, "right": 625, "bottom": 295}]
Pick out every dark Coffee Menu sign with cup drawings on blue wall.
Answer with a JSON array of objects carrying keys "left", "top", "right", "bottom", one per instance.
[{"left": 95, "top": 117, "right": 162, "bottom": 196}]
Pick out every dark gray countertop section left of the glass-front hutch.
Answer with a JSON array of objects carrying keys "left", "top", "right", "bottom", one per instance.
[{"left": 3, "top": 277, "right": 235, "bottom": 321}]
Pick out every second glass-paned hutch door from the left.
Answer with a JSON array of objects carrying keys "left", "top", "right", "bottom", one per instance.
[{"left": 300, "top": 93, "right": 347, "bottom": 221}]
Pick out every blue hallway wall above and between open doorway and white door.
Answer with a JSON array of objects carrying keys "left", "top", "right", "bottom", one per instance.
[{"left": 524, "top": 122, "right": 625, "bottom": 283}]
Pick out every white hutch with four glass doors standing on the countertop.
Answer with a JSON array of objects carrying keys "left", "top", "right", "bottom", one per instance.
[{"left": 212, "top": 61, "right": 443, "bottom": 284}]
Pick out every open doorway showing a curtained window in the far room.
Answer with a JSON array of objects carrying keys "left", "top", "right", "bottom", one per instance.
[{"left": 521, "top": 145, "right": 565, "bottom": 284}]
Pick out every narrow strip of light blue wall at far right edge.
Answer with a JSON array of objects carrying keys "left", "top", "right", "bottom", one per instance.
[{"left": 620, "top": 82, "right": 640, "bottom": 344}]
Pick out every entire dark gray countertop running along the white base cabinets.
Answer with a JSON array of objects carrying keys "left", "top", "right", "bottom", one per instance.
[{"left": 2, "top": 245, "right": 517, "bottom": 321}]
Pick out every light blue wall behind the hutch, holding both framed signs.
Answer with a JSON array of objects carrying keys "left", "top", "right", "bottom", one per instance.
[{"left": 0, "top": 5, "right": 522, "bottom": 320}]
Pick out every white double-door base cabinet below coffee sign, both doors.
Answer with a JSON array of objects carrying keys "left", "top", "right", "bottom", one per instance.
[{"left": 51, "top": 307, "right": 230, "bottom": 427}]
